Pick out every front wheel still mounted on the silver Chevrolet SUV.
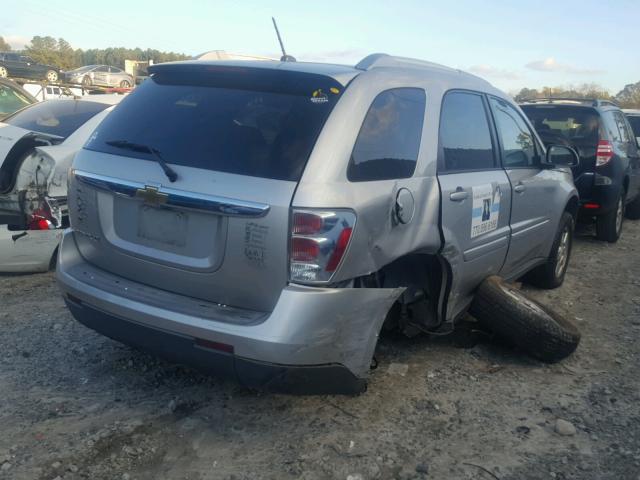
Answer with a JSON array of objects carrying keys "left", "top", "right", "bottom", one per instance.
[{"left": 524, "top": 212, "right": 574, "bottom": 289}]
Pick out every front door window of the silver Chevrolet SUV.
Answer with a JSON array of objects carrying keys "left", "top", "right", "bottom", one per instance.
[{"left": 490, "top": 97, "right": 539, "bottom": 168}]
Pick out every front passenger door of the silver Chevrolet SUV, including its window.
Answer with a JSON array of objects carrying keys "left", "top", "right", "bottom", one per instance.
[{"left": 489, "top": 97, "right": 563, "bottom": 276}]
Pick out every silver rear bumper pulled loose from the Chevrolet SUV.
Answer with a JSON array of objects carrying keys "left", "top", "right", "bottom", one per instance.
[{"left": 57, "top": 230, "right": 403, "bottom": 393}]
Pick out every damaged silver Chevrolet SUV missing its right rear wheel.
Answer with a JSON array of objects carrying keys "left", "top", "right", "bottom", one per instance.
[{"left": 57, "top": 54, "right": 578, "bottom": 393}]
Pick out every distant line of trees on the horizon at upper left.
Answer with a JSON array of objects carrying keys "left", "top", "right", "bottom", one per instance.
[{"left": 0, "top": 36, "right": 191, "bottom": 70}]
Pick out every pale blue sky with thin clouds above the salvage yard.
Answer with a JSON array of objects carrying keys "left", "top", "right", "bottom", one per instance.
[{"left": 0, "top": 0, "right": 640, "bottom": 94}]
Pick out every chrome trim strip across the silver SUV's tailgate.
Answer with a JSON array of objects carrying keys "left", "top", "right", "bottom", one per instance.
[{"left": 72, "top": 170, "right": 271, "bottom": 218}]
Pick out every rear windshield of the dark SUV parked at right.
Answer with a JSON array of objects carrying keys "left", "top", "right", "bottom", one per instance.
[{"left": 522, "top": 105, "right": 601, "bottom": 147}]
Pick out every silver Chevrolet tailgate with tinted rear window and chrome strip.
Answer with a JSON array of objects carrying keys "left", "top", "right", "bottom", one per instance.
[{"left": 69, "top": 64, "right": 350, "bottom": 311}]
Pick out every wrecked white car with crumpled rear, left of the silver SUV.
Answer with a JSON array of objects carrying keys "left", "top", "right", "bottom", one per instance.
[{"left": 0, "top": 95, "right": 123, "bottom": 272}]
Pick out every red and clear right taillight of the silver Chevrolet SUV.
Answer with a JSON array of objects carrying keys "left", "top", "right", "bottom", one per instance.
[{"left": 289, "top": 210, "right": 356, "bottom": 283}]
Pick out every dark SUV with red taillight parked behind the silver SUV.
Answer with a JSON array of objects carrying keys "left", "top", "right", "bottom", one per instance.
[{"left": 520, "top": 98, "right": 640, "bottom": 242}]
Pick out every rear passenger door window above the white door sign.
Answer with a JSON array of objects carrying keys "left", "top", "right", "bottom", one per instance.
[{"left": 440, "top": 92, "right": 495, "bottom": 171}]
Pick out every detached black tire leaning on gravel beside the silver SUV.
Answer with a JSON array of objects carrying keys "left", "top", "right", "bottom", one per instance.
[{"left": 469, "top": 276, "right": 580, "bottom": 363}]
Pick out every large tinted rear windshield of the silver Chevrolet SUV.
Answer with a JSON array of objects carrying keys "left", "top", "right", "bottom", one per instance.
[{"left": 85, "top": 66, "right": 343, "bottom": 181}]
